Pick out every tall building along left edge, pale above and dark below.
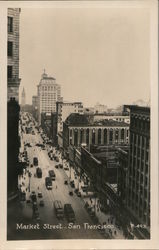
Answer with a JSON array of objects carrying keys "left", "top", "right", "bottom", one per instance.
[{"left": 7, "top": 8, "right": 20, "bottom": 200}]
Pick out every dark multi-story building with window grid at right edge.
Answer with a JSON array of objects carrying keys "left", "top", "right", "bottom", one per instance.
[{"left": 127, "top": 106, "right": 150, "bottom": 232}]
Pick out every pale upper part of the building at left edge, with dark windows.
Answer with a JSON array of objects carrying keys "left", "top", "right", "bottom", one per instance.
[{"left": 7, "top": 8, "right": 21, "bottom": 102}]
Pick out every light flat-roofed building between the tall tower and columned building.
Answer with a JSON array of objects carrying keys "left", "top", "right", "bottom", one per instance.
[{"left": 56, "top": 102, "right": 83, "bottom": 132}]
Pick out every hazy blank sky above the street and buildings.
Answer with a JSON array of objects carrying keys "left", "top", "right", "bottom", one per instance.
[{"left": 20, "top": 8, "right": 150, "bottom": 107}]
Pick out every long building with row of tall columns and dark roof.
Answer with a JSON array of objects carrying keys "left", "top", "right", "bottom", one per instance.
[{"left": 63, "top": 114, "right": 129, "bottom": 150}]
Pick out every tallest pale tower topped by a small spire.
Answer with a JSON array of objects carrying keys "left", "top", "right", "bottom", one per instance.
[{"left": 37, "top": 70, "right": 61, "bottom": 123}]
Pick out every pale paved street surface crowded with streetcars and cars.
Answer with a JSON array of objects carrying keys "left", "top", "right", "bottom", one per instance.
[{"left": 20, "top": 124, "right": 103, "bottom": 239}]
